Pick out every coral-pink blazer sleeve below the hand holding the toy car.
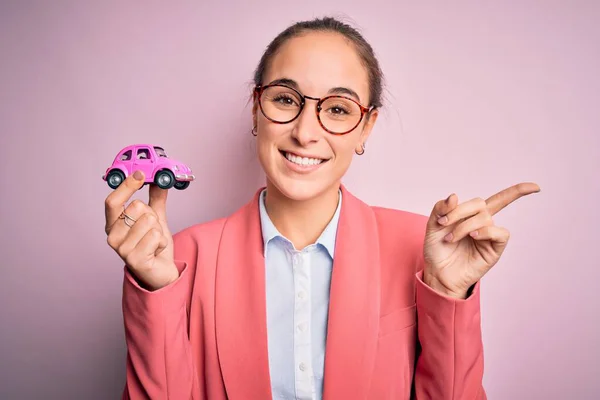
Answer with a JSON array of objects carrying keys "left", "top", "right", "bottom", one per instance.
[{"left": 122, "top": 231, "right": 202, "bottom": 400}]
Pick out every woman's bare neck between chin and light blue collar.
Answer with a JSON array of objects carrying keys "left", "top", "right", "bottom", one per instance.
[{"left": 265, "top": 180, "right": 339, "bottom": 250}]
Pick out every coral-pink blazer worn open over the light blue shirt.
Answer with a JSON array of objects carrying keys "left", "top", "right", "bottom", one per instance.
[{"left": 123, "top": 186, "right": 486, "bottom": 400}]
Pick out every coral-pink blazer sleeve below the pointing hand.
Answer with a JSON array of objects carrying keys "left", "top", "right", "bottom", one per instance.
[{"left": 413, "top": 270, "right": 487, "bottom": 400}]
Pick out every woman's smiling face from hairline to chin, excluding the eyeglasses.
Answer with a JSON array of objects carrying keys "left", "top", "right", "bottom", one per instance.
[{"left": 253, "top": 32, "right": 377, "bottom": 200}]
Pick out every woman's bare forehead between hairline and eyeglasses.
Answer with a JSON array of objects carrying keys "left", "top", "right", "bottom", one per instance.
[{"left": 263, "top": 32, "right": 369, "bottom": 102}]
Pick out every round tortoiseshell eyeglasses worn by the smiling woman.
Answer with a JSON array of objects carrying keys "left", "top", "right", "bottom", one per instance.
[{"left": 254, "top": 84, "right": 375, "bottom": 135}]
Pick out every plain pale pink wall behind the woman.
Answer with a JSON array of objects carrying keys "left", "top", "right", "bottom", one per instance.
[{"left": 0, "top": 0, "right": 600, "bottom": 399}]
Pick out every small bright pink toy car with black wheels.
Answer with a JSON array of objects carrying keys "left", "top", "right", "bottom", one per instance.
[{"left": 102, "top": 144, "right": 195, "bottom": 190}]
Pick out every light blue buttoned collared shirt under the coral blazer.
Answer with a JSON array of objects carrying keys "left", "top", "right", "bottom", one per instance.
[{"left": 259, "top": 189, "right": 342, "bottom": 400}]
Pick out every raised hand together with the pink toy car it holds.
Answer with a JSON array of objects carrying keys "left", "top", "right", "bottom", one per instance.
[{"left": 102, "top": 144, "right": 194, "bottom": 290}]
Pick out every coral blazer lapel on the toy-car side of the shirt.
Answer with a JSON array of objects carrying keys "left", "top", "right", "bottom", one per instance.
[{"left": 215, "top": 190, "right": 272, "bottom": 400}]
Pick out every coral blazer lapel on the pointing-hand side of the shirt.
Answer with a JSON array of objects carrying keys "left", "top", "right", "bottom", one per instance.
[{"left": 323, "top": 186, "right": 380, "bottom": 400}]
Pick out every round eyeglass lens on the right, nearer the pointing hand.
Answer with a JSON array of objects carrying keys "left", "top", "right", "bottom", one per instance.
[{"left": 319, "top": 97, "right": 362, "bottom": 133}]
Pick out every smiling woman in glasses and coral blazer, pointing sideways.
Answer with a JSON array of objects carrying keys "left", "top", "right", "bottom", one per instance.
[{"left": 106, "top": 18, "right": 539, "bottom": 400}]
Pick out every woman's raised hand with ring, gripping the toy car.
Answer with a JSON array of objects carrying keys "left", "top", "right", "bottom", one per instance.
[{"left": 105, "top": 171, "right": 179, "bottom": 290}]
